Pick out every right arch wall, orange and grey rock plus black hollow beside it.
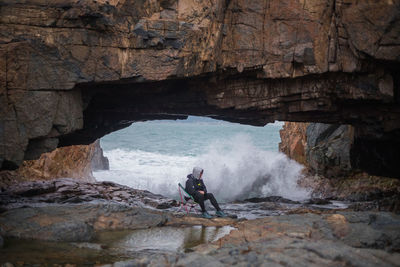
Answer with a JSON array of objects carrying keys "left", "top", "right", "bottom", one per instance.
[{"left": 279, "top": 122, "right": 400, "bottom": 178}]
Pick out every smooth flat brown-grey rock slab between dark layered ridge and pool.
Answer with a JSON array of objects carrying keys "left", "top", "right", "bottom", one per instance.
[{"left": 0, "top": 203, "right": 165, "bottom": 242}]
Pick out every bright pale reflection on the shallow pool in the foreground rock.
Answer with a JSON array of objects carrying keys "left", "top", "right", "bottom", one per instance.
[{"left": 112, "top": 226, "right": 234, "bottom": 252}]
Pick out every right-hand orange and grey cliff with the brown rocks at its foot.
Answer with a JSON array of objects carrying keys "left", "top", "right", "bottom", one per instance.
[{"left": 279, "top": 122, "right": 400, "bottom": 206}]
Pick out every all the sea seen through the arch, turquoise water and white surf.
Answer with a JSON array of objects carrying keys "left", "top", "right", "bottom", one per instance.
[{"left": 94, "top": 117, "right": 308, "bottom": 202}]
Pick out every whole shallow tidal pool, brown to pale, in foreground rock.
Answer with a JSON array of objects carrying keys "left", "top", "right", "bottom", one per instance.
[{"left": 0, "top": 226, "right": 235, "bottom": 266}]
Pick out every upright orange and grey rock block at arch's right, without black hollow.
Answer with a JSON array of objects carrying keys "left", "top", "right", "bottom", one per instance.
[{"left": 279, "top": 122, "right": 354, "bottom": 177}]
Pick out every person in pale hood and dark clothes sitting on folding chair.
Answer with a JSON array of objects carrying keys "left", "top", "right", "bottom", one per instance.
[{"left": 185, "top": 167, "right": 226, "bottom": 219}]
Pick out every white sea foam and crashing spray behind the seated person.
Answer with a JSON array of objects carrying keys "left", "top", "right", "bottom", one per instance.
[{"left": 94, "top": 134, "right": 309, "bottom": 202}]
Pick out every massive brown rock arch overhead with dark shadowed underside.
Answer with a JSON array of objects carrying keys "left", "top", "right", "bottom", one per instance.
[{"left": 0, "top": 0, "right": 400, "bottom": 178}]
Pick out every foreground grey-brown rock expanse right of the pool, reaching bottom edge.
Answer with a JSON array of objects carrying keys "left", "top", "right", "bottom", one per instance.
[{"left": 78, "top": 212, "right": 400, "bottom": 267}]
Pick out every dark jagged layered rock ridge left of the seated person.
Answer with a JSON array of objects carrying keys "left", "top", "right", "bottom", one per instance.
[{"left": 0, "top": 178, "right": 178, "bottom": 209}]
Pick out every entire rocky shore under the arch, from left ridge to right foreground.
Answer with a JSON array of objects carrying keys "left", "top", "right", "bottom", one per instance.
[{"left": 0, "top": 179, "right": 400, "bottom": 266}]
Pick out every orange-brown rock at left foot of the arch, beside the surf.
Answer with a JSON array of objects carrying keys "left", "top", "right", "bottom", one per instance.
[{"left": 0, "top": 141, "right": 109, "bottom": 191}]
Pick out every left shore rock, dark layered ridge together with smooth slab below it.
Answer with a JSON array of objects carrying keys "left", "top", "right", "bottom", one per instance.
[{"left": 0, "top": 179, "right": 180, "bottom": 241}]
